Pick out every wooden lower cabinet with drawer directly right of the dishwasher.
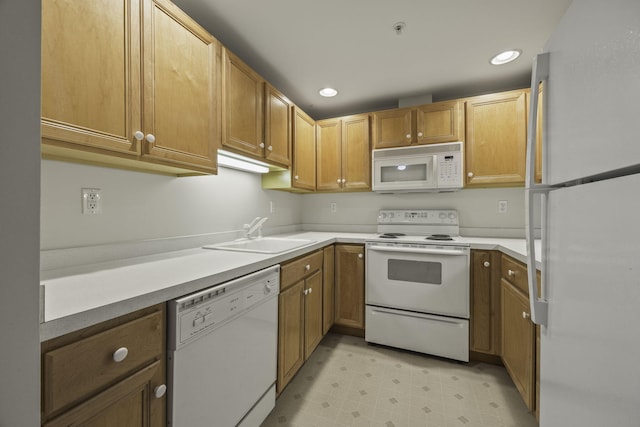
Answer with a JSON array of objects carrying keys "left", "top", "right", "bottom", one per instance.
[{"left": 276, "top": 251, "right": 324, "bottom": 393}]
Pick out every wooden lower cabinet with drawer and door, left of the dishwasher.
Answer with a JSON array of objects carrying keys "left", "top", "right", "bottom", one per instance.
[{"left": 41, "top": 304, "right": 166, "bottom": 427}]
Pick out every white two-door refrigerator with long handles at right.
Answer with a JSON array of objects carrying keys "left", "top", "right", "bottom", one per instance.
[{"left": 526, "top": 0, "right": 640, "bottom": 427}]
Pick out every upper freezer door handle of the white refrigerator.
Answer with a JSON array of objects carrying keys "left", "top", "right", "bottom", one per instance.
[{"left": 525, "top": 52, "right": 549, "bottom": 188}]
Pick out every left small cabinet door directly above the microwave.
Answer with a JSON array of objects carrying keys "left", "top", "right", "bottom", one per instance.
[{"left": 373, "top": 108, "right": 412, "bottom": 148}]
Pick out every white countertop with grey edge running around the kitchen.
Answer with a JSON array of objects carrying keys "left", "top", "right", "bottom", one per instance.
[{"left": 40, "top": 232, "right": 540, "bottom": 341}]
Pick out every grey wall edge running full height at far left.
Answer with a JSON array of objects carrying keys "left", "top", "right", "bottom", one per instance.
[{"left": 0, "top": 0, "right": 40, "bottom": 427}]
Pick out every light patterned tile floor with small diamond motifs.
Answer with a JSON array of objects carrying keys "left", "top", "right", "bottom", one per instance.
[{"left": 262, "top": 334, "right": 538, "bottom": 427}]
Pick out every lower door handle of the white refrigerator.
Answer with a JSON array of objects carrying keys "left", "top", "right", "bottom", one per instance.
[{"left": 524, "top": 186, "right": 551, "bottom": 326}]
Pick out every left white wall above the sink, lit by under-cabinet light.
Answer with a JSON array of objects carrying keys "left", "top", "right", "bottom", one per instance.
[{"left": 41, "top": 160, "right": 302, "bottom": 250}]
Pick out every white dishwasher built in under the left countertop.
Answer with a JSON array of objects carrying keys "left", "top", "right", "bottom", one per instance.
[{"left": 168, "top": 265, "right": 280, "bottom": 427}]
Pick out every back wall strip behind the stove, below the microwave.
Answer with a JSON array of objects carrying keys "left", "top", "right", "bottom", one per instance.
[{"left": 302, "top": 188, "right": 525, "bottom": 237}]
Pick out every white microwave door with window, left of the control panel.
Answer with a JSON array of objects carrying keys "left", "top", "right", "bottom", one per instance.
[{"left": 374, "top": 156, "right": 437, "bottom": 190}]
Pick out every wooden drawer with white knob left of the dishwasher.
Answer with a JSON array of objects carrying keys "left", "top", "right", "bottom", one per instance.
[{"left": 42, "top": 311, "right": 164, "bottom": 416}]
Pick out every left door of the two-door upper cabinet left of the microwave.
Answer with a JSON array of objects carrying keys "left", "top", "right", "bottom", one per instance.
[{"left": 316, "top": 119, "right": 342, "bottom": 190}]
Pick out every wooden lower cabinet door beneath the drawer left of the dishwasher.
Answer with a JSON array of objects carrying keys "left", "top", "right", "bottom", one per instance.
[{"left": 43, "top": 361, "right": 165, "bottom": 427}]
